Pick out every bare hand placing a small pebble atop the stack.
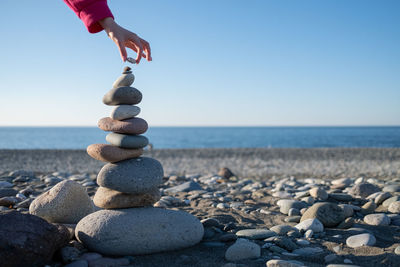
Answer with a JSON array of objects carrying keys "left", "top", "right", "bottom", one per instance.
[{"left": 99, "top": 18, "right": 152, "bottom": 64}]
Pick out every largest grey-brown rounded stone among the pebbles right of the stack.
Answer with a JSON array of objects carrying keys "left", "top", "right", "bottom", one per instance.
[{"left": 300, "top": 202, "right": 345, "bottom": 227}]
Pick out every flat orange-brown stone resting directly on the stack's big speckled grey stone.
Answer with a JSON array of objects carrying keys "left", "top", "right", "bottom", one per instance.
[{"left": 86, "top": 144, "right": 143, "bottom": 162}]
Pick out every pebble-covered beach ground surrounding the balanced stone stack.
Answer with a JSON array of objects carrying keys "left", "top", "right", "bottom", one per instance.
[{"left": 0, "top": 149, "right": 400, "bottom": 267}]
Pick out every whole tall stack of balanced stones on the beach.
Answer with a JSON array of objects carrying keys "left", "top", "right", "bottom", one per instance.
[{"left": 75, "top": 67, "right": 204, "bottom": 255}]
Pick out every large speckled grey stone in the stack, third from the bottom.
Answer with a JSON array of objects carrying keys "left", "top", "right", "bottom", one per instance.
[{"left": 97, "top": 157, "right": 164, "bottom": 194}]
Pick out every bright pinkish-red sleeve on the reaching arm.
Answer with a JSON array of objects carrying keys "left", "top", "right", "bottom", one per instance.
[{"left": 63, "top": 0, "right": 114, "bottom": 33}]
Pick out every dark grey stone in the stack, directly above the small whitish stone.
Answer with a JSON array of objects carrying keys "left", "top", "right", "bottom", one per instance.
[{"left": 103, "top": 86, "right": 142, "bottom": 106}]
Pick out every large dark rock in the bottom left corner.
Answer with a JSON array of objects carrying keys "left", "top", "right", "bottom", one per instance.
[{"left": 0, "top": 211, "right": 68, "bottom": 267}]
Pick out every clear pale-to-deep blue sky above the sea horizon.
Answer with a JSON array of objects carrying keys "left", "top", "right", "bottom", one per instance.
[{"left": 0, "top": 0, "right": 400, "bottom": 126}]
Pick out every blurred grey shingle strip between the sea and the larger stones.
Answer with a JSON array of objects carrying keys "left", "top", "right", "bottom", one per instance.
[{"left": 0, "top": 148, "right": 400, "bottom": 178}]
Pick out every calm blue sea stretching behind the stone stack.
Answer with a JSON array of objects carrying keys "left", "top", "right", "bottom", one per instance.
[{"left": 0, "top": 127, "right": 400, "bottom": 149}]
